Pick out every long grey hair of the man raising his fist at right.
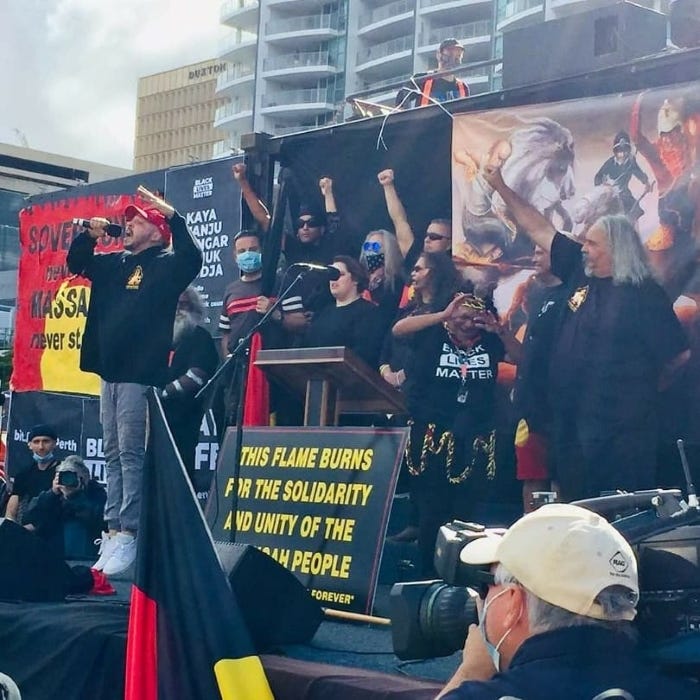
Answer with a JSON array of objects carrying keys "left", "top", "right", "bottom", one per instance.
[{"left": 593, "top": 214, "right": 654, "bottom": 287}]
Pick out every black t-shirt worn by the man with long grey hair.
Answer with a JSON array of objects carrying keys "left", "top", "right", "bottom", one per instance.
[{"left": 550, "top": 234, "right": 688, "bottom": 432}]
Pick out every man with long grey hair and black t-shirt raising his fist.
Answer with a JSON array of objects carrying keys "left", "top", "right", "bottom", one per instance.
[{"left": 484, "top": 166, "right": 690, "bottom": 501}]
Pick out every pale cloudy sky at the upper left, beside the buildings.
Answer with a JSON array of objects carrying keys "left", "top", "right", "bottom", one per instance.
[{"left": 0, "top": 0, "right": 224, "bottom": 168}]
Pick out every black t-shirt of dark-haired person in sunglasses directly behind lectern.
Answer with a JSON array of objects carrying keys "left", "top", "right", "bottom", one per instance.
[{"left": 301, "top": 299, "right": 383, "bottom": 367}]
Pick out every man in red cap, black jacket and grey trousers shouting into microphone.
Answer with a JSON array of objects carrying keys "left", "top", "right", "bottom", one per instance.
[{"left": 67, "top": 188, "right": 202, "bottom": 576}]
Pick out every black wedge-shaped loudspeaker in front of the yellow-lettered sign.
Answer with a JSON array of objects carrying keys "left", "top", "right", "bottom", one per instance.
[{"left": 216, "top": 542, "right": 323, "bottom": 652}]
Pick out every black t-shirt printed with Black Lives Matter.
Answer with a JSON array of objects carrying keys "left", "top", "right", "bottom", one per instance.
[{"left": 406, "top": 325, "right": 505, "bottom": 435}]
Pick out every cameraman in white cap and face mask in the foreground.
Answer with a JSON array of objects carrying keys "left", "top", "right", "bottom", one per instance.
[{"left": 438, "top": 503, "right": 700, "bottom": 700}]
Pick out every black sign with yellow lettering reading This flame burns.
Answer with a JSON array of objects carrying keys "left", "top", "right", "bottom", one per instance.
[{"left": 207, "top": 428, "right": 407, "bottom": 613}]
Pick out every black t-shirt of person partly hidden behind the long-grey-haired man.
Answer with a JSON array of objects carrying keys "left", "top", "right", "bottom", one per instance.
[{"left": 513, "top": 283, "right": 566, "bottom": 431}]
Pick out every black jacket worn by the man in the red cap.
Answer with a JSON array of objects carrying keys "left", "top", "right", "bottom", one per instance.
[{"left": 67, "top": 213, "right": 202, "bottom": 386}]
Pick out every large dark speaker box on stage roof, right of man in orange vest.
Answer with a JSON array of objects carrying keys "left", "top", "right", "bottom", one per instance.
[{"left": 503, "top": 2, "right": 667, "bottom": 88}]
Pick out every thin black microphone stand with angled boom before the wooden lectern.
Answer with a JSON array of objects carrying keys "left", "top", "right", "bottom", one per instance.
[{"left": 195, "top": 269, "right": 312, "bottom": 543}]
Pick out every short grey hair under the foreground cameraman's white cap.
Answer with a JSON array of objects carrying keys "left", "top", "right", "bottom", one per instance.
[{"left": 494, "top": 564, "right": 636, "bottom": 638}]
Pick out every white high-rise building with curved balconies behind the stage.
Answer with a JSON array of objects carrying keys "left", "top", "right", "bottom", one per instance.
[{"left": 213, "top": 0, "right": 669, "bottom": 157}]
